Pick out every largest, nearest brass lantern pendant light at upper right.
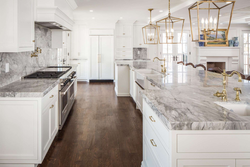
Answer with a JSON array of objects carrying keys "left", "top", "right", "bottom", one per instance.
[{"left": 188, "top": 0, "right": 235, "bottom": 43}]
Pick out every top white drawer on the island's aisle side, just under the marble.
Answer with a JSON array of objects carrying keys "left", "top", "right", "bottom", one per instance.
[{"left": 143, "top": 100, "right": 170, "bottom": 150}]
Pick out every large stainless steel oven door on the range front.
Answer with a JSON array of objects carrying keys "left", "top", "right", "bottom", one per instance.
[{"left": 59, "top": 79, "right": 75, "bottom": 129}]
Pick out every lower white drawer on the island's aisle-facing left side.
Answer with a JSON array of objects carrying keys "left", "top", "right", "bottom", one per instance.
[{"left": 144, "top": 120, "right": 170, "bottom": 167}]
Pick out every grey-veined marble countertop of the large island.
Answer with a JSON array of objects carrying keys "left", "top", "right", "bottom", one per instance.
[{"left": 114, "top": 61, "right": 250, "bottom": 130}]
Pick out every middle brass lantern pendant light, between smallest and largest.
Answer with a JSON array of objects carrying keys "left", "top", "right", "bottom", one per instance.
[{"left": 156, "top": 0, "right": 185, "bottom": 44}]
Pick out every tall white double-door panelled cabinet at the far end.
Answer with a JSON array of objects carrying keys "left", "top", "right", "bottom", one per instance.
[{"left": 90, "top": 36, "right": 114, "bottom": 80}]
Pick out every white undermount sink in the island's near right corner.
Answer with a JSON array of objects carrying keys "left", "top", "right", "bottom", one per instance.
[{"left": 215, "top": 102, "right": 250, "bottom": 116}]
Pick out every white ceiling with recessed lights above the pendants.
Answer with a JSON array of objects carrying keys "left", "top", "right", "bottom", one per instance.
[{"left": 74, "top": 0, "right": 250, "bottom": 24}]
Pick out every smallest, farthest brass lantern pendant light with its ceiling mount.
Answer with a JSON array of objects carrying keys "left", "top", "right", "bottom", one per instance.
[{"left": 142, "top": 9, "right": 159, "bottom": 44}]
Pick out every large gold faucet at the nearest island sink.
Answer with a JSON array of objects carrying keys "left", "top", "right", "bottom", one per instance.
[{"left": 214, "top": 69, "right": 242, "bottom": 102}]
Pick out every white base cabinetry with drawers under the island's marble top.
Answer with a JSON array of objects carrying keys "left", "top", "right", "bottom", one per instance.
[{"left": 142, "top": 99, "right": 250, "bottom": 167}]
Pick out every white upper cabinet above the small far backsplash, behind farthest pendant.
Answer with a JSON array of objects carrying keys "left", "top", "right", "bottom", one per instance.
[{"left": 133, "top": 25, "right": 148, "bottom": 48}]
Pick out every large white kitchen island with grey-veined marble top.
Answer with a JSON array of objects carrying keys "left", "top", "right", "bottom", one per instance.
[{"left": 117, "top": 62, "right": 250, "bottom": 167}]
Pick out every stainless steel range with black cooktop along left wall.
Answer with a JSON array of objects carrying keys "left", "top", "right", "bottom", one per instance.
[{"left": 24, "top": 66, "right": 77, "bottom": 130}]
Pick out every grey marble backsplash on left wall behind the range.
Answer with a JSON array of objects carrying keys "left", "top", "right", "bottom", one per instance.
[{"left": 0, "top": 25, "right": 60, "bottom": 87}]
